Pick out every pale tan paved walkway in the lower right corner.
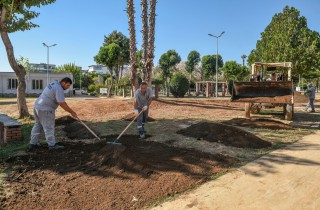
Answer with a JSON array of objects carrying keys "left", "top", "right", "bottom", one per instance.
[{"left": 154, "top": 131, "right": 320, "bottom": 210}]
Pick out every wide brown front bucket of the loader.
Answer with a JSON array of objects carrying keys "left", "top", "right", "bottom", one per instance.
[{"left": 231, "top": 81, "right": 293, "bottom": 104}]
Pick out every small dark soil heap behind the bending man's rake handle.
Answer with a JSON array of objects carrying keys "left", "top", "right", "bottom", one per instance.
[{"left": 63, "top": 121, "right": 95, "bottom": 139}]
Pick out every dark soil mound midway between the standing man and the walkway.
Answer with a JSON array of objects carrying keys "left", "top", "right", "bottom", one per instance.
[{"left": 177, "top": 122, "right": 271, "bottom": 149}]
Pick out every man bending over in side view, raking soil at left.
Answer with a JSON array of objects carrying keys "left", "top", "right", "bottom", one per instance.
[{"left": 29, "top": 77, "right": 78, "bottom": 150}]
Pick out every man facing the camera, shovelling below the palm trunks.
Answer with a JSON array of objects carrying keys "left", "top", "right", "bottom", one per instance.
[{"left": 133, "top": 82, "right": 152, "bottom": 139}]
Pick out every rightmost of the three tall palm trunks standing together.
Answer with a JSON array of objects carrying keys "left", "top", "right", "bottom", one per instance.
[{"left": 146, "top": 0, "right": 157, "bottom": 86}]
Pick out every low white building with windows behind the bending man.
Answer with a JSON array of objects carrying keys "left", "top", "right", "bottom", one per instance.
[{"left": 0, "top": 72, "right": 73, "bottom": 97}]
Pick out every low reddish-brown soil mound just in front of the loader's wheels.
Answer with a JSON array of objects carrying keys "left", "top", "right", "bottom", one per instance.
[{"left": 223, "top": 118, "right": 295, "bottom": 130}]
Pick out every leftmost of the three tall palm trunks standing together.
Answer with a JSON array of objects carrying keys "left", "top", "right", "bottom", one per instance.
[{"left": 127, "top": 0, "right": 139, "bottom": 92}]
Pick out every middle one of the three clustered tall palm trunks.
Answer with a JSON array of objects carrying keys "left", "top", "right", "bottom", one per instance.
[{"left": 141, "top": 0, "right": 149, "bottom": 81}]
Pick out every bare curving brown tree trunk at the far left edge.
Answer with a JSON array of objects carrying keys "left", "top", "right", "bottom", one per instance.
[{"left": 0, "top": 6, "right": 30, "bottom": 118}]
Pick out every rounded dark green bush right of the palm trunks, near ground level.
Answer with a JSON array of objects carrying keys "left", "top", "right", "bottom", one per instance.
[{"left": 170, "top": 73, "right": 189, "bottom": 98}]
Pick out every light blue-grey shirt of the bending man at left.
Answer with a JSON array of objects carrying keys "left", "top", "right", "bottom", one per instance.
[{"left": 34, "top": 82, "right": 65, "bottom": 111}]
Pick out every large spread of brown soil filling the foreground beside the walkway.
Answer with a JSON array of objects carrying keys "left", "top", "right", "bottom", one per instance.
[{"left": 1, "top": 136, "right": 237, "bottom": 209}]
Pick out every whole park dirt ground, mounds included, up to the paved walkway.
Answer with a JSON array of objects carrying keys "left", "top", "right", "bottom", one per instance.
[{"left": 0, "top": 94, "right": 319, "bottom": 209}]
